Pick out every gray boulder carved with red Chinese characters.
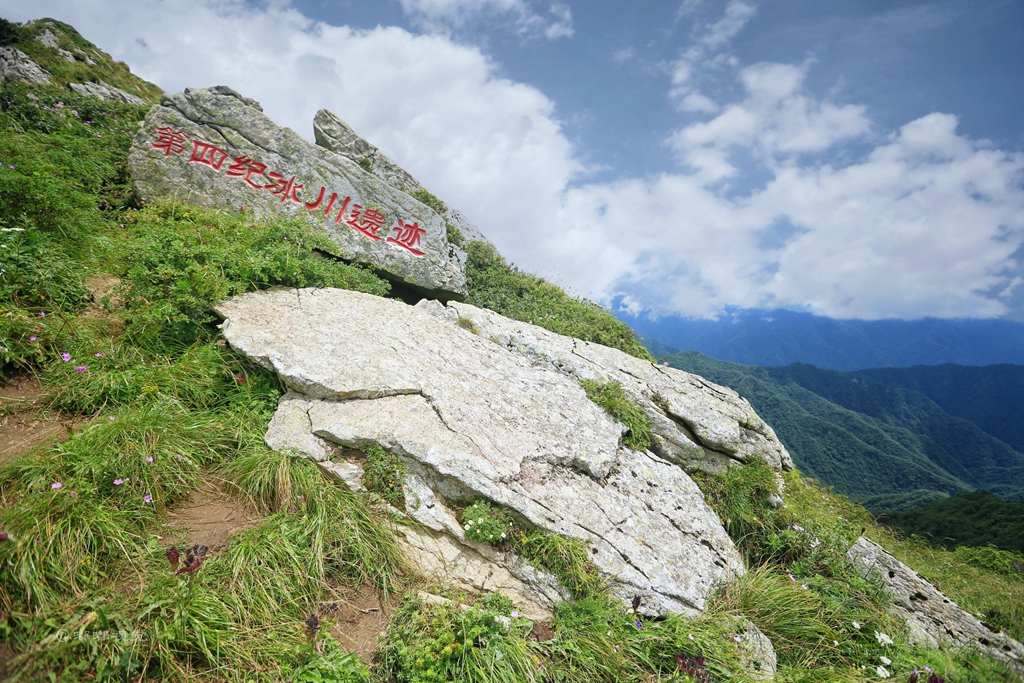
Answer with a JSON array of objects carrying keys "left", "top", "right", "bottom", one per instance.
[{"left": 129, "top": 86, "right": 466, "bottom": 299}]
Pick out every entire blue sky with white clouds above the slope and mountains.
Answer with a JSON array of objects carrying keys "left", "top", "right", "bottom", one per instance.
[{"left": 0, "top": 0, "right": 1024, "bottom": 319}]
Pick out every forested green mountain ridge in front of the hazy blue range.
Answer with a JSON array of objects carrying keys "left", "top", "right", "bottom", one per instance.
[{"left": 659, "top": 351, "right": 1024, "bottom": 511}]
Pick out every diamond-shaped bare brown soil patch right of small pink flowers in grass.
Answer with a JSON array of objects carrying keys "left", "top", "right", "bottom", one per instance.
[{"left": 164, "top": 481, "right": 260, "bottom": 551}]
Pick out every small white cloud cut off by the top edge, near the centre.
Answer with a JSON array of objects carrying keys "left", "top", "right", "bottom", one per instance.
[{"left": 398, "top": 0, "right": 573, "bottom": 40}]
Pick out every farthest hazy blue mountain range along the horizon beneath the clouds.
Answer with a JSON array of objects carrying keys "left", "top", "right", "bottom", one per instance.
[{"left": 615, "top": 308, "right": 1024, "bottom": 371}]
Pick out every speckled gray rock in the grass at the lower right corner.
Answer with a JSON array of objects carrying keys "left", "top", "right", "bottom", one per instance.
[{"left": 847, "top": 537, "right": 1024, "bottom": 671}]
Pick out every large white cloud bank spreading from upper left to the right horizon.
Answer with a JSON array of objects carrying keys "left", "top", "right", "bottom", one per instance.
[{"left": 0, "top": 0, "right": 1024, "bottom": 317}]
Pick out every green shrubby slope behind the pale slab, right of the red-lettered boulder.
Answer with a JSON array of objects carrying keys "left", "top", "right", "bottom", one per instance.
[{"left": 466, "top": 242, "right": 653, "bottom": 360}]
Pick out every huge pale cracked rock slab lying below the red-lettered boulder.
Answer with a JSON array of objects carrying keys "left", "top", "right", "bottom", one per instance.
[{"left": 217, "top": 290, "right": 743, "bottom": 614}]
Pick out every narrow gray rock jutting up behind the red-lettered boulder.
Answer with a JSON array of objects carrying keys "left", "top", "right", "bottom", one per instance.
[{"left": 313, "top": 110, "right": 490, "bottom": 245}]
